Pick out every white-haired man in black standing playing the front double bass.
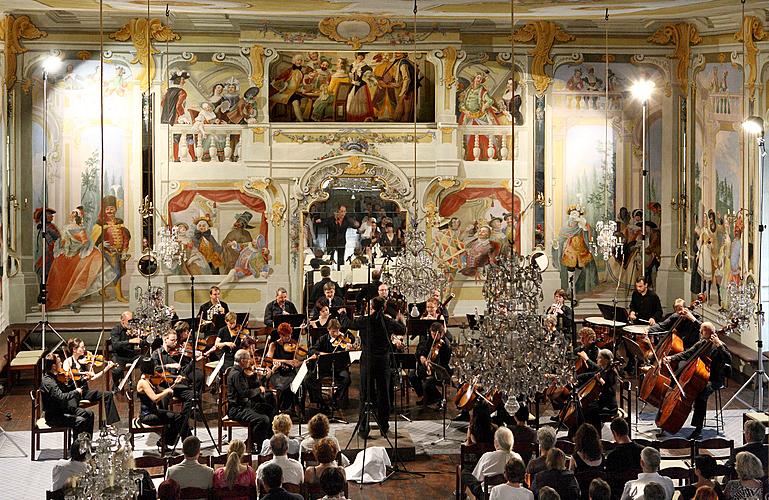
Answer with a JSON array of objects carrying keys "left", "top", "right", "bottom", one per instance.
[{"left": 663, "top": 321, "right": 732, "bottom": 439}]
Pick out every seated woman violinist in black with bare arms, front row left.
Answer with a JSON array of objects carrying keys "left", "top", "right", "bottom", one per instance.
[{"left": 136, "top": 358, "right": 192, "bottom": 453}]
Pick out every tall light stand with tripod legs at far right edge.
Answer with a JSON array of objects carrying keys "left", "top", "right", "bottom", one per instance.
[{"left": 722, "top": 124, "right": 769, "bottom": 412}]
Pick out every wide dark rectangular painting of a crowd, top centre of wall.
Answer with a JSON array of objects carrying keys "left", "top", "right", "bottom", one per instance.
[{"left": 269, "top": 51, "right": 435, "bottom": 122}]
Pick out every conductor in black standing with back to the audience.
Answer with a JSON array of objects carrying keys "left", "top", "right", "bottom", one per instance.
[{"left": 350, "top": 297, "right": 406, "bottom": 438}]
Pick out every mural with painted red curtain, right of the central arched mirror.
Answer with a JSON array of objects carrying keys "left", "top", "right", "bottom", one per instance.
[{"left": 432, "top": 187, "right": 521, "bottom": 280}]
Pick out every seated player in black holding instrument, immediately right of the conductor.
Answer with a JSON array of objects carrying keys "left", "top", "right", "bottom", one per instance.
[{"left": 409, "top": 321, "right": 451, "bottom": 406}]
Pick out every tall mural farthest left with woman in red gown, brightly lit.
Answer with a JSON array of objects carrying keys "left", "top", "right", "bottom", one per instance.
[{"left": 31, "top": 60, "right": 141, "bottom": 312}]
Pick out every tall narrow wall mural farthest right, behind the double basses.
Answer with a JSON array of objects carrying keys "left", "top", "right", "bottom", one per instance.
[{"left": 689, "top": 58, "right": 745, "bottom": 308}]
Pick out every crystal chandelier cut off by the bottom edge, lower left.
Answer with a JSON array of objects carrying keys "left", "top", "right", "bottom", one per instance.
[{"left": 65, "top": 426, "right": 142, "bottom": 500}]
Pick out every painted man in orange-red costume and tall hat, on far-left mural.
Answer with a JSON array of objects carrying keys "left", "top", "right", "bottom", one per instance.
[{"left": 91, "top": 195, "right": 131, "bottom": 302}]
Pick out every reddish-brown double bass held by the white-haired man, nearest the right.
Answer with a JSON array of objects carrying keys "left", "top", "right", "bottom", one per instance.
[{"left": 655, "top": 320, "right": 738, "bottom": 434}]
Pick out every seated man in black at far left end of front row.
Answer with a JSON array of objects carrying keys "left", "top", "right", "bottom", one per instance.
[{"left": 40, "top": 354, "right": 93, "bottom": 442}]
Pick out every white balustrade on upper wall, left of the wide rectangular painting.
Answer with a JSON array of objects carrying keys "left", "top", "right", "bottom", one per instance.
[{"left": 169, "top": 123, "right": 240, "bottom": 163}]
